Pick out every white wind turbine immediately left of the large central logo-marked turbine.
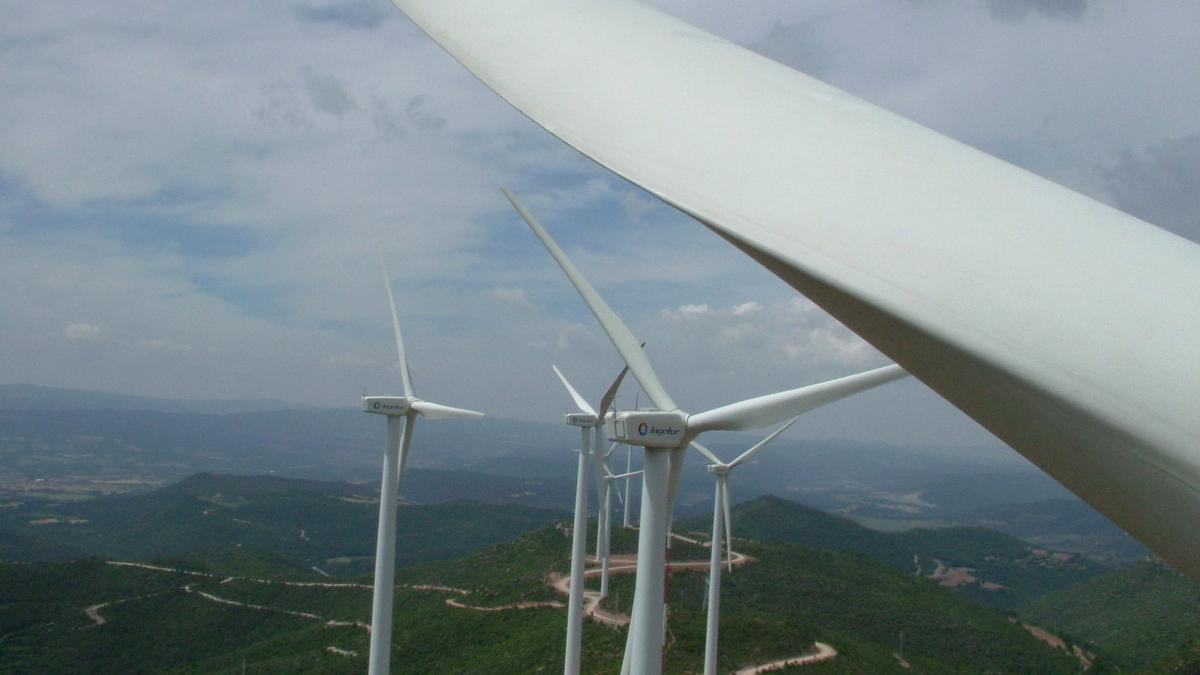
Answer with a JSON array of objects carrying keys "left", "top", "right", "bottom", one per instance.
[{"left": 551, "top": 365, "right": 629, "bottom": 675}]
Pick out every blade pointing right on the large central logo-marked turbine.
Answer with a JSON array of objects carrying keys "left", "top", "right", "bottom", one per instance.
[{"left": 688, "top": 364, "right": 908, "bottom": 434}]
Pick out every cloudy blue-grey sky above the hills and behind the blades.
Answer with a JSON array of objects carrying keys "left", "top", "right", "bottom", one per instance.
[{"left": 0, "top": 0, "right": 1200, "bottom": 447}]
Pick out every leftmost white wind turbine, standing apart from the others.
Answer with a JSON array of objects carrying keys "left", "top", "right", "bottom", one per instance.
[{"left": 362, "top": 269, "right": 484, "bottom": 675}]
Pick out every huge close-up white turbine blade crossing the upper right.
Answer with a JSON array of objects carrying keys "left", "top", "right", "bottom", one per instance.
[{"left": 394, "top": 0, "right": 1200, "bottom": 583}]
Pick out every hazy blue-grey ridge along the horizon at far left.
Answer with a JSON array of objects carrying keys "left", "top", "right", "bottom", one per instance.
[{"left": 0, "top": 384, "right": 313, "bottom": 414}]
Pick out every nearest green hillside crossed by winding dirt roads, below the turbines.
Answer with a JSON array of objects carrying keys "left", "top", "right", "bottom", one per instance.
[{"left": 0, "top": 516, "right": 1078, "bottom": 673}]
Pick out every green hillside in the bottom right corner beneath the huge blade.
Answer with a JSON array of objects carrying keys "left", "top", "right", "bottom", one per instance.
[{"left": 1019, "top": 560, "right": 1200, "bottom": 673}]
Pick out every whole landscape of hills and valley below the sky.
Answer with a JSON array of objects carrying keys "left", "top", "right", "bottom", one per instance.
[{"left": 0, "top": 392, "right": 1200, "bottom": 673}]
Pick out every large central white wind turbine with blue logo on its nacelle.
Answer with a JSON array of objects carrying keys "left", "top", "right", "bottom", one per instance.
[{"left": 504, "top": 190, "right": 907, "bottom": 674}]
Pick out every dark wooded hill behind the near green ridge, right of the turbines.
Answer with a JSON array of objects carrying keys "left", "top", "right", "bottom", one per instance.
[{"left": 684, "top": 496, "right": 1104, "bottom": 608}]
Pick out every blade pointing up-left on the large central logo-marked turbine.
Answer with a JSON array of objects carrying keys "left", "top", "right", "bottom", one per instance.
[{"left": 504, "top": 190, "right": 679, "bottom": 411}]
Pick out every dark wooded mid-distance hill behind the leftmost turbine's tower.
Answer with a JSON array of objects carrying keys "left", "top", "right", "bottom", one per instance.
[{"left": 0, "top": 473, "right": 560, "bottom": 574}]
